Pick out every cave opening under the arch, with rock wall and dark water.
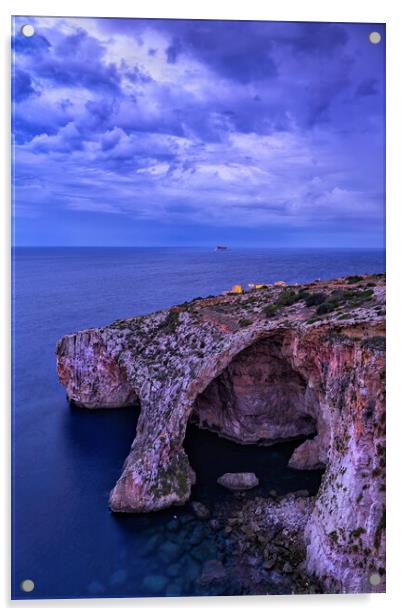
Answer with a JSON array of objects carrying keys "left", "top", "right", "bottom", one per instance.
[{"left": 184, "top": 335, "right": 323, "bottom": 498}]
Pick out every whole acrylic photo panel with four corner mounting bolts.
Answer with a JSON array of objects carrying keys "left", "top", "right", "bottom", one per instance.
[{"left": 12, "top": 16, "right": 385, "bottom": 599}]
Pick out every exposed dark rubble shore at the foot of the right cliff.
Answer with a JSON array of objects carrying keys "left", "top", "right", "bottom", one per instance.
[{"left": 201, "top": 491, "right": 323, "bottom": 595}]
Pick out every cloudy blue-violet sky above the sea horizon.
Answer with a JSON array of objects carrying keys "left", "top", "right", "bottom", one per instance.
[{"left": 12, "top": 17, "right": 385, "bottom": 248}]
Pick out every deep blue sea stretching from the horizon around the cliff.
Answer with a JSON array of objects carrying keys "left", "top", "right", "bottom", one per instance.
[{"left": 12, "top": 248, "right": 385, "bottom": 598}]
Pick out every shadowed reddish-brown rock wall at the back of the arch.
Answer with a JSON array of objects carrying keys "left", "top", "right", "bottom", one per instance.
[{"left": 192, "top": 334, "right": 316, "bottom": 444}]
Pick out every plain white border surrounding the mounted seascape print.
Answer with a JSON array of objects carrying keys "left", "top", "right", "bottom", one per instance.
[{"left": 0, "top": 0, "right": 402, "bottom": 616}]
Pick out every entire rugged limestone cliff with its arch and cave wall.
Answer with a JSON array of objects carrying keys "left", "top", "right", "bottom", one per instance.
[{"left": 57, "top": 276, "right": 385, "bottom": 592}]
